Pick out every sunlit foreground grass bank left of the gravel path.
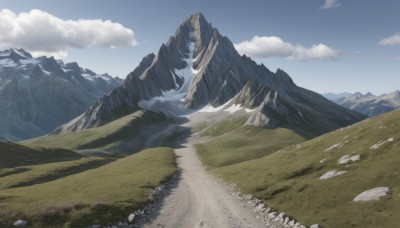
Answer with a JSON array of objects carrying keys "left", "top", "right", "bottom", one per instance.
[{"left": 0, "top": 148, "right": 176, "bottom": 227}]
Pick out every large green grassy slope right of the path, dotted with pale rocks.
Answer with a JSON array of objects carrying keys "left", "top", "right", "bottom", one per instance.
[{"left": 199, "top": 111, "right": 400, "bottom": 227}]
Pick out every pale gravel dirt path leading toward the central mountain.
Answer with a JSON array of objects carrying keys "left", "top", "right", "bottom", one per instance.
[{"left": 144, "top": 142, "right": 282, "bottom": 228}]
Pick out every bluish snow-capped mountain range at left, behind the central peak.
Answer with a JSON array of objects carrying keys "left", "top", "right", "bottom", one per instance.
[{"left": 0, "top": 49, "right": 122, "bottom": 141}]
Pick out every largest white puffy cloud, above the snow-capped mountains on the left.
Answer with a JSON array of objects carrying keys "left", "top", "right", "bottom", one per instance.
[{"left": 0, "top": 9, "right": 138, "bottom": 57}]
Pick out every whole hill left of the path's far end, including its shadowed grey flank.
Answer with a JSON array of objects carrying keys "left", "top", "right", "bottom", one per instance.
[{"left": 23, "top": 110, "right": 189, "bottom": 155}]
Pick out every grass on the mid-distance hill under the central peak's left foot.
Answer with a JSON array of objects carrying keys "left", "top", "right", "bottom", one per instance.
[{"left": 24, "top": 111, "right": 167, "bottom": 152}]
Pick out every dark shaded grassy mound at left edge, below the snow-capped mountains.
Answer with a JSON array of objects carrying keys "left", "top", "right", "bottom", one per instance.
[{"left": 0, "top": 141, "right": 82, "bottom": 169}]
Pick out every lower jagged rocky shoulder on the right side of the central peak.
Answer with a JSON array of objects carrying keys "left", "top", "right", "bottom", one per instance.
[{"left": 233, "top": 79, "right": 363, "bottom": 135}]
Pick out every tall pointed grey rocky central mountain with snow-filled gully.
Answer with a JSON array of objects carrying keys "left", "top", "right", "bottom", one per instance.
[{"left": 55, "top": 13, "right": 364, "bottom": 134}]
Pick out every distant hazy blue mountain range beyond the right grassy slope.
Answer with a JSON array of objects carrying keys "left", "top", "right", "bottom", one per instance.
[{"left": 333, "top": 90, "right": 400, "bottom": 116}]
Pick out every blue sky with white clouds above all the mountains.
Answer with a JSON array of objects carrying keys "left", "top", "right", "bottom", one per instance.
[{"left": 0, "top": 0, "right": 400, "bottom": 94}]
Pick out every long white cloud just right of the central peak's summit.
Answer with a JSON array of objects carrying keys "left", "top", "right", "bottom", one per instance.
[{"left": 235, "top": 36, "right": 341, "bottom": 61}]
